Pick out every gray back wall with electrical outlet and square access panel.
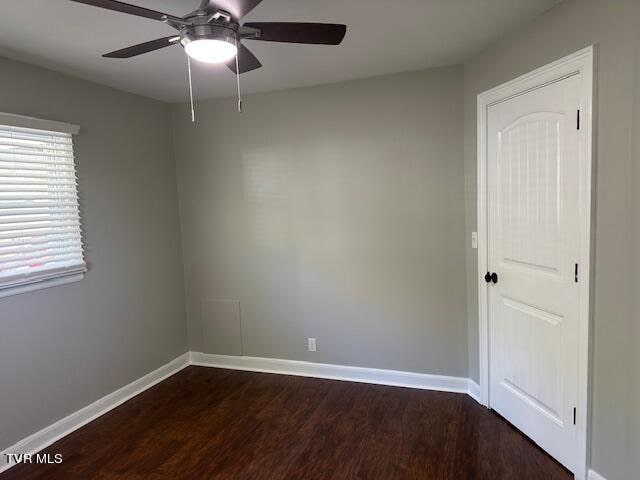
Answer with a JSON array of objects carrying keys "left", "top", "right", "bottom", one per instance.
[{"left": 173, "top": 67, "right": 468, "bottom": 377}]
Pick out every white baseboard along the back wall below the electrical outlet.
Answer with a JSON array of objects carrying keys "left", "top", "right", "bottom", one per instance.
[{"left": 190, "top": 352, "right": 480, "bottom": 398}]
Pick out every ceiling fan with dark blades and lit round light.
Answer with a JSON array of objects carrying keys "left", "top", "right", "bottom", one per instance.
[{"left": 71, "top": 0, "right": 347, "bottom": 74}]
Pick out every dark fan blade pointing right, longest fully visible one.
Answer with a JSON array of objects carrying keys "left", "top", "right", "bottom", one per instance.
[{"left": 244, "top": 22, "right": 347, "bottom": 45}]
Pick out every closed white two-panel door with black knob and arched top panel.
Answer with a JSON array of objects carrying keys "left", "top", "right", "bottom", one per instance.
[{"left": 487, "top": 75, "right": 580, "bottom": 470}]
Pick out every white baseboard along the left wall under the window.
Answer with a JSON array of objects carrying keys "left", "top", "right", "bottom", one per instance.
[{"left": 0, "top": 353, "right": 189, "bottom": 472}]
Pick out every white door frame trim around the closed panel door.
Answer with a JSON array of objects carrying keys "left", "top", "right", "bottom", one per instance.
[{"left": 477, "top": 46, "right": 594, "bottom": 480}]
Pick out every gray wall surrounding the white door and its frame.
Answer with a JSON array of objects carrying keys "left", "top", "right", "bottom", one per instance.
[{"left": 464, "top": 0, "right": 640, "bottom": 480}]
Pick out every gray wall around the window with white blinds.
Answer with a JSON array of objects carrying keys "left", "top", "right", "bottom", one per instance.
[{"left": 0, "top": 55, "right": 187, "bottom": 450}]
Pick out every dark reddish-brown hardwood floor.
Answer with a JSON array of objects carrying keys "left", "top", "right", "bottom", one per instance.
[{"left": 0, "top": 367, "right": 572, "bottom": 480}]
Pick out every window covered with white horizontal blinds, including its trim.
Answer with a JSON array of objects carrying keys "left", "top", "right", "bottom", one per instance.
[{"left": 0, "top": 114, "right": 86, "bottom": 296}]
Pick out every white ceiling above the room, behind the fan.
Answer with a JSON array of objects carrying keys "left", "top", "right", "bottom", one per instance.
[{"left": 0, "top": 0, "right": 562, "bottom": 102}]
